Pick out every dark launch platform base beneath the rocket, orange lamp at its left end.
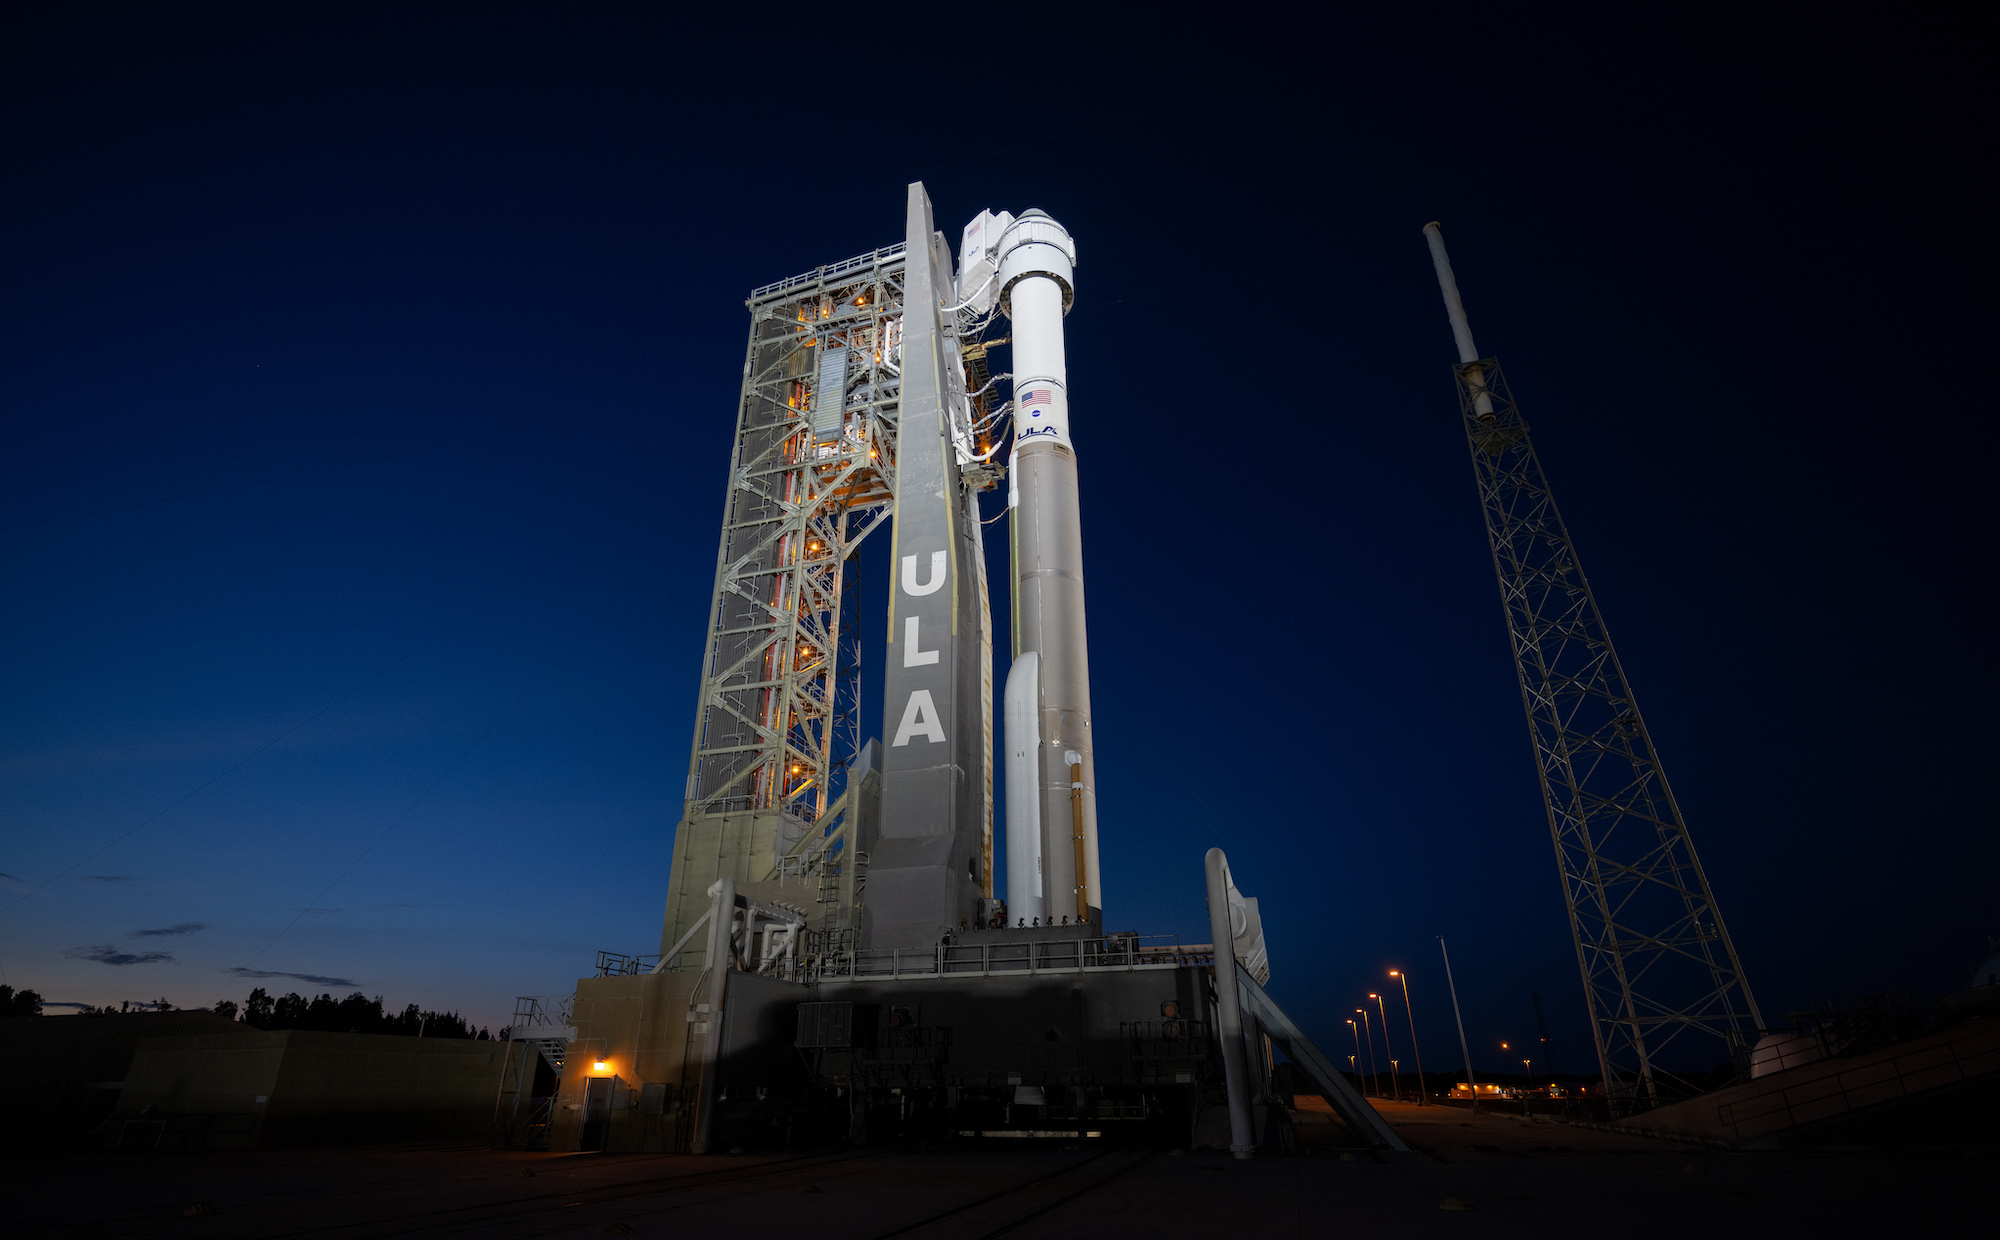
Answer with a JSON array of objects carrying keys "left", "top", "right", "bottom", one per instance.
[{"left": 548, "top": 932, "right": 1404, "bottom": 1154}]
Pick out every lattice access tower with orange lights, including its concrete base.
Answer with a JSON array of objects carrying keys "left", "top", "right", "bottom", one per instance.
[{"left": 660, "top": 235, "right": 906, "bottom": 968}]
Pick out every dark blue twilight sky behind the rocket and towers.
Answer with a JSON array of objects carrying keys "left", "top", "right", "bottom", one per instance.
[{"left": 0, "top": 4, "right": 2000, "bottom": 1072}]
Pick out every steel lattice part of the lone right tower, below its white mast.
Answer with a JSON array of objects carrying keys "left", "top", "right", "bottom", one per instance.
[{"left": 1456, "top": 358, "right": 1764, "bottom": 1102}]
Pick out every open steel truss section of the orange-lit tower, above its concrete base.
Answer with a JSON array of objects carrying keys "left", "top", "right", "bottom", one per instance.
[{"left": 682, "top": 246, "right": 904, "bottom": 850}]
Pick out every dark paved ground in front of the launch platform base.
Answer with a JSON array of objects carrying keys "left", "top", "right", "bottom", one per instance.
[{"left": 0, "top": 1104, "right": 2000, "bottom": 1240}]
